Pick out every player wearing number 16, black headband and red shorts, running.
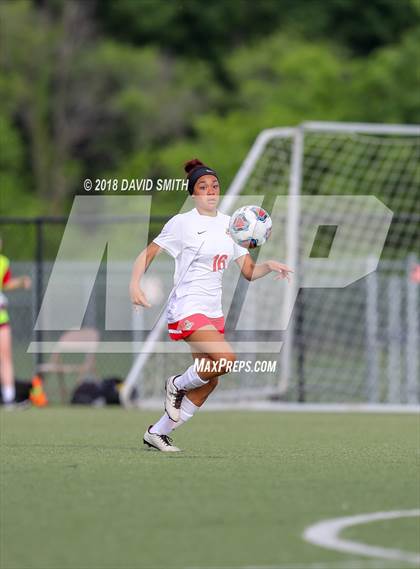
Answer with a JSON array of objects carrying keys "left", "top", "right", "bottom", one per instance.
[{"left": 130, "top": 159, "right": 293, "bottom": 452}]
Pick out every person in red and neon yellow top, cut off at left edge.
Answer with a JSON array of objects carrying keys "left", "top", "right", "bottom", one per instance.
[{"left": 0, "top": 238, "right": 31, "bottom": 408}]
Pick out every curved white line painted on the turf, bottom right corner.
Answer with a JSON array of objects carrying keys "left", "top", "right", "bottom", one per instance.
[{"left": 303, "top": 510, "right": 420, "bottom": 564}]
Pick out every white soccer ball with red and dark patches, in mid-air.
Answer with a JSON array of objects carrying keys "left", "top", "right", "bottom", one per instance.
[{"left": 229, "top": 205, "right": 273, "bottom": 249}]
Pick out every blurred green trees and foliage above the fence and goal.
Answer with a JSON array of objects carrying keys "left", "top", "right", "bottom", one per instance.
[{"left": 0, "top": 0, "right": 420, "bottom": 229}]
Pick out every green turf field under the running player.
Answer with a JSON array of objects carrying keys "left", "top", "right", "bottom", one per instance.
[{"left": 0, "top": 407, "right": 420, "bottom": 569}]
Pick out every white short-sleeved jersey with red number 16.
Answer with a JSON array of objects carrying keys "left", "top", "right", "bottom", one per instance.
[{"left": 153, "top": 208, "right": 248, "bottom": 322}]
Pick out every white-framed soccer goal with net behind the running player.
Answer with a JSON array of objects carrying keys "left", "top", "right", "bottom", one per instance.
[{"left": 124, "top": 123, "right": 420, "bottom": 404}]
